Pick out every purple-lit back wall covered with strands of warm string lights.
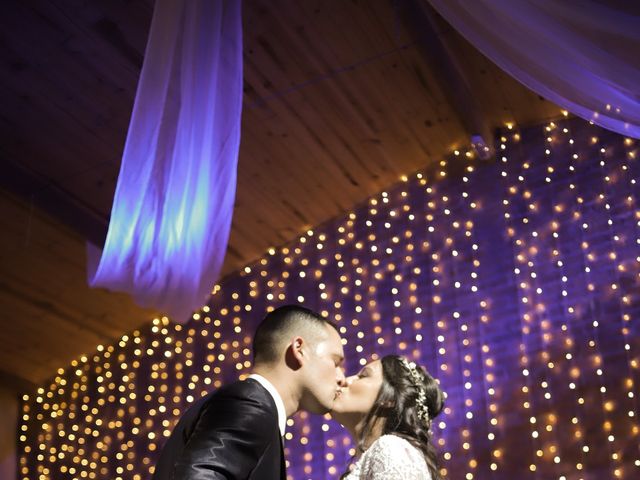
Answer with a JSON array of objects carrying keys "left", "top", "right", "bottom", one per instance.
[{"left": 19, "top": 120, "right": 640, "bottom": 480}]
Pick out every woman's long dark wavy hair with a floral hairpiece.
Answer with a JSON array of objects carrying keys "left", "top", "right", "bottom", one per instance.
[{"left": 345, "top": 355, "right": 445, "bottom": 480}]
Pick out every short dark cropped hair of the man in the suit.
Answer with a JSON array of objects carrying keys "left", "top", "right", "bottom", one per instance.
[{"left": 253, "top": 305, "right": 338, "bottom": 363}]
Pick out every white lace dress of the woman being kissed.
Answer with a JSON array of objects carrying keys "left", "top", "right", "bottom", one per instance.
[{"left": 345, "top": 435, "right": 431, "bottom": 480}]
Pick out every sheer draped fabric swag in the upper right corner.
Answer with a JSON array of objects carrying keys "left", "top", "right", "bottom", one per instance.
[{"left": 428, "top": 0, "right": 640, "bottom": 138}]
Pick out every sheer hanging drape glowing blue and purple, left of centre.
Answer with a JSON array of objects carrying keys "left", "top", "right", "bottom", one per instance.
[{"left": 90, "top": 0, "right": 242, "bottom": 322}]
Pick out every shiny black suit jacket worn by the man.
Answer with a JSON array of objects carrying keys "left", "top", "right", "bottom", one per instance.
[{"left": 153, "top": 378, "right": 286, "bottom": 480}]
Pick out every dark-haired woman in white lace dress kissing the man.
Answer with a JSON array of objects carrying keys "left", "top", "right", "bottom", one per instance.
[{"left": 331, "top": 355, "right": 445, "bottom": 480}]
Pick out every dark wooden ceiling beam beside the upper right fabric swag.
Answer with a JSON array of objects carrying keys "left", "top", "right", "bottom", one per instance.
[{"left": 397, "top": 0, "right": 494, "bottom": 160}]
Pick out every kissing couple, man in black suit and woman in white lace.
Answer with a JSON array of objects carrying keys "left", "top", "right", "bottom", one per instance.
[{"left": 153, "top": 305, "right": 445, "bottom": 480}]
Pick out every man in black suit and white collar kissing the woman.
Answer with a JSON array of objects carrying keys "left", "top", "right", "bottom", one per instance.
[{"left": 153, "top": 305, "right": 345, "bottom": 480}]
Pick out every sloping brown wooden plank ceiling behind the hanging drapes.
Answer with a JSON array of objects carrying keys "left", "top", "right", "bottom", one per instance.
[{"left": 0, "top": 0, "right": 559, "bottom": 389}]
